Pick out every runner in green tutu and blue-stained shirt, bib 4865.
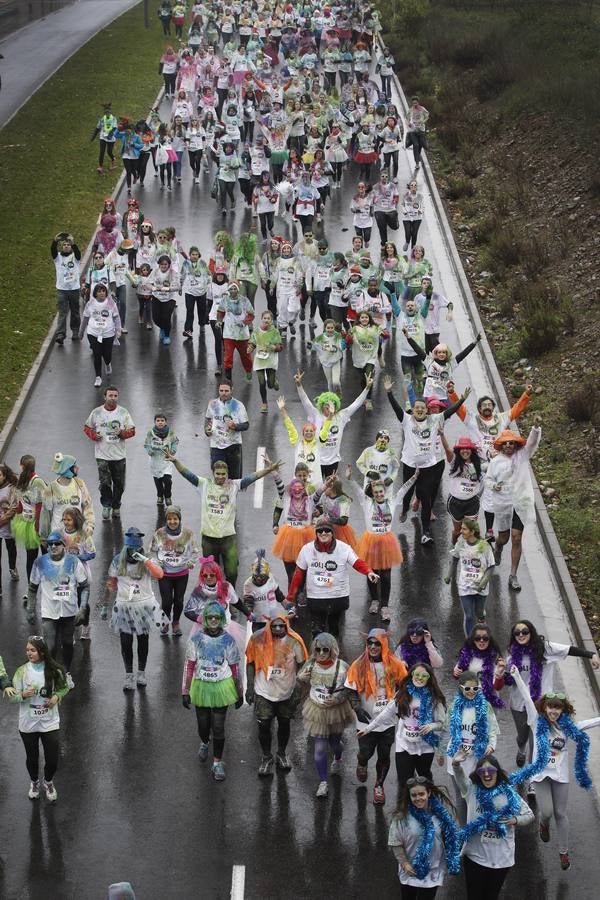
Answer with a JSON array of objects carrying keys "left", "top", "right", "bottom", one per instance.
[{"left": 181, "top": 601, "right": 244, "bottom": 781}]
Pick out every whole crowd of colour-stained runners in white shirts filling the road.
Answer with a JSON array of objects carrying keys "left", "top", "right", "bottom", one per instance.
[{"left": 0, "top": 0, "right": 600, "bottom": 900}]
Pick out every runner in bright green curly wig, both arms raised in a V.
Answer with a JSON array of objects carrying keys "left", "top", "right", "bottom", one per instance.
[{"left": 294, "top": 369, "right": 373, "bottom": 480}]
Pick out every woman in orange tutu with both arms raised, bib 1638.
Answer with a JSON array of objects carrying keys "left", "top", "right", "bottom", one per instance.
[{"left": 346, "top": 466, "right": 417, "bottom": 622}]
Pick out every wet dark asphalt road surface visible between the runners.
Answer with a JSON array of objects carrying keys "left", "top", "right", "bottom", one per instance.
[{"left": 0, "top": 45, "right": 600, "bottom": 900}]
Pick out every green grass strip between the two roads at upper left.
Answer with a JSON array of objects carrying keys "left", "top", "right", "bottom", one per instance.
[{"left": 0, "top": 4, "right": 165, "bottom": 427}]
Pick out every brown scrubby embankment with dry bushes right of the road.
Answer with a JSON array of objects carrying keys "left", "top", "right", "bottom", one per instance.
[{"left": 380, "top": 0, "right": 600, "bottom": 641}]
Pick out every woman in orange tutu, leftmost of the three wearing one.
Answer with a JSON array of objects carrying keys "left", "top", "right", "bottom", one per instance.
[{"left": 271, "top": 462, "right": 315, "bottom": 592}]
